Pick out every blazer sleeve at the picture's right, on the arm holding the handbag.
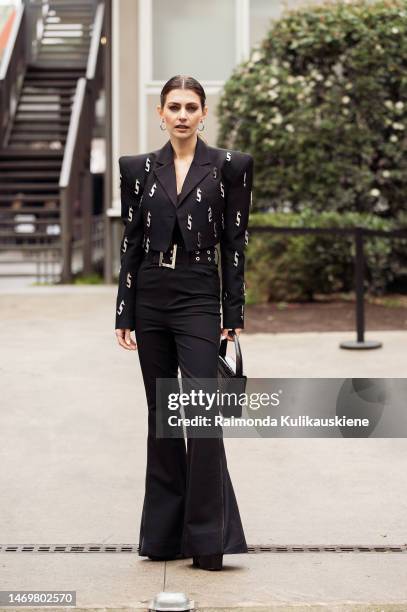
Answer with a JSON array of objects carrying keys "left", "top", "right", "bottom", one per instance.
[{"left": 220, "top": 154, "right": 253, "bottom": 329}]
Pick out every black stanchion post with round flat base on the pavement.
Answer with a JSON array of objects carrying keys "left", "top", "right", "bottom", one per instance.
[{"left": 339, "top": 226, "right": 382, "bottom": 349}]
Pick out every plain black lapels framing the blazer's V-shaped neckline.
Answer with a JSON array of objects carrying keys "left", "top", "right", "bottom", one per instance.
[{"left": 154, "top": 137, "right": 211, "bottom": 206}]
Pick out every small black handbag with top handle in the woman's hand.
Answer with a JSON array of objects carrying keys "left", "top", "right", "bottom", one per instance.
[{"left": 218, "top": 330, "right": 247, "bottom": 418}]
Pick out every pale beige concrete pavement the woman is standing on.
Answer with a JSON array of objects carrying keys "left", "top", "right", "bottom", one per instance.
[{"left": 0, "top": 286, "right": 407, "bottom": 612}]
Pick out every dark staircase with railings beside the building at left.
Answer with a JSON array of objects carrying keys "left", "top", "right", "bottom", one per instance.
[{"left": 0, "top": 0, "right": 105, "bottom": 281}]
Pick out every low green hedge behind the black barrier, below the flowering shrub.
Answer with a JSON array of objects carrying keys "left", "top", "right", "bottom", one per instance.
[{"left": 246, "top": 209, "right": 407, "bottom": 303}]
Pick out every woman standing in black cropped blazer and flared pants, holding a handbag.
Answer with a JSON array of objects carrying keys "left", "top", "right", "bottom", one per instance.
[{"left": 115, "top": 76, "right": 253, "bottom": 570}]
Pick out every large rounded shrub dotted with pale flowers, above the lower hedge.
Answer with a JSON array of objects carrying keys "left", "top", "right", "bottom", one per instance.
[{"left": 217, "top": 0, "right": 407, "bottom": 218}]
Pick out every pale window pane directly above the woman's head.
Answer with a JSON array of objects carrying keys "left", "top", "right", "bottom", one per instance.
[{"left": 152, "top": 0, "right": 236, "bottom": 81}]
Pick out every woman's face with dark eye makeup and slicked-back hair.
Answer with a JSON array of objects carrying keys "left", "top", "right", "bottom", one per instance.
[{"left": 157, "top": 89, "right": 208, "bottom": 140}]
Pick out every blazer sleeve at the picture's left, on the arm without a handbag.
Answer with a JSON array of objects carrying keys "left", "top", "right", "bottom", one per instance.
[{"left": 115, "top": 156, "right": 144, "bottom": 331}]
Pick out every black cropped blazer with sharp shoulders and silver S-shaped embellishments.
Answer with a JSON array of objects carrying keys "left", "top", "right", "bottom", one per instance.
[{"left": 115, "top": 137, "right": 253, "bottom": 330}]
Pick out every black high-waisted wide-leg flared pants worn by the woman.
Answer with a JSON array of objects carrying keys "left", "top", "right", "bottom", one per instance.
[{"left": 135, "top": 251, "right": 248, "bottom": 557}]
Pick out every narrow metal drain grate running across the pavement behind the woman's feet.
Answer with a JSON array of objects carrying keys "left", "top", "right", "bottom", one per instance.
[{"left": 0, "top": 544, "right": 407, "bottom": 554}]
